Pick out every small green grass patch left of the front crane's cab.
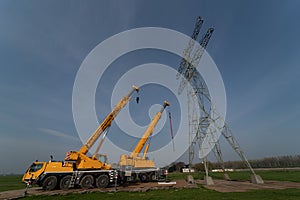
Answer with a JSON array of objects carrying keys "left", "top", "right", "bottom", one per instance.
[{"left": 0, "top": 175, "right": 25, "bottom": 192}]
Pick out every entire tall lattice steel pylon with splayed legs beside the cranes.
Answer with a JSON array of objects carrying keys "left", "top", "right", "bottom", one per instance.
[{"left": 176, "top": 17, "right": 263, "bottom": 183}]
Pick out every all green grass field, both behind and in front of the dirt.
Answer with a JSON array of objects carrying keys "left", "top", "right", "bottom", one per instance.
[{"left": 0, "top": 171, "right": 300, "bottom": 200}]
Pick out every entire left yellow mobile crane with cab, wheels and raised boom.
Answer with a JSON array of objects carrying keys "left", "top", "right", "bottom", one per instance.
[{"left": 22, "top": 85, "right": 139, "bottom": 190}]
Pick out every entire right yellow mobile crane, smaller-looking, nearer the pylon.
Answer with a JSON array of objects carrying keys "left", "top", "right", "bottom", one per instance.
[{"left": 119, "top": 101, "right": 170, "bottom": 182}]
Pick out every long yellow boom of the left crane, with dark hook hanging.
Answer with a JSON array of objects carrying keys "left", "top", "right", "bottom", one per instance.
[{"left": 78, "top": 85, "right": 139, "bottom": 154}]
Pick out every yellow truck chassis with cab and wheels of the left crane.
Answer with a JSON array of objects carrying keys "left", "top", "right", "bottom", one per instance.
[{"left": 23, "top": 161, "right": 117, "bottom": 190}]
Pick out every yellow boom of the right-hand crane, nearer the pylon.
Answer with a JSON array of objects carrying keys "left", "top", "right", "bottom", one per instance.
[{"left": 131, "top": 101, "right": 170, "bottom": 157}]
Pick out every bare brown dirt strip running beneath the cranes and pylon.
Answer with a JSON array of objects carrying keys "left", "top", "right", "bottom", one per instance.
[{"left": 0, "top": 180, "right": 300, "bottom": 199}]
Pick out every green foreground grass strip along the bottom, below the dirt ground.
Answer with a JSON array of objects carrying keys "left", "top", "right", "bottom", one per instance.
[{"left": 24, "top": 187, "right": 300, "bottom": 200}]
